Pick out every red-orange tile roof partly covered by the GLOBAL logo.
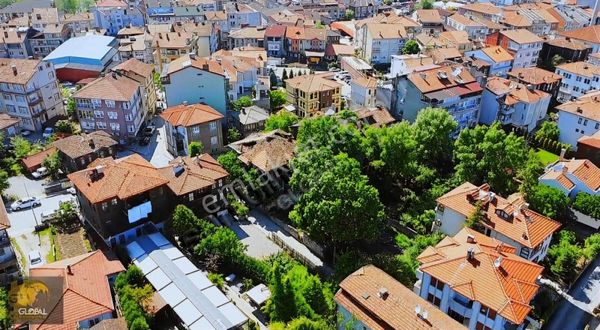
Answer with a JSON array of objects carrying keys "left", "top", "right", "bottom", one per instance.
[{"left": 29, "top": 250, "right": 125, "bottom": 330}]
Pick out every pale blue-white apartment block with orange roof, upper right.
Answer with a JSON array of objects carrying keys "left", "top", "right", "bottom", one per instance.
[{"left": 486, "top": 29, "right": 543, "bottom": 69}]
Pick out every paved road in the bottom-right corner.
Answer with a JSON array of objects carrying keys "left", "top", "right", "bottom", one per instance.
[{"left": 544, "top": 256, "right": 600, "bottom": 330}]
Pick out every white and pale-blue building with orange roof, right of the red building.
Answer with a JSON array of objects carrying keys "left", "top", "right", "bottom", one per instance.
[{"left": 360, "top": 23, "right": 408, "bottom": 64}]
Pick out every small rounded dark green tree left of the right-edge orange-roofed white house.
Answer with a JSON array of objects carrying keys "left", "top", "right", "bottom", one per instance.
[{"left": 527, "top": 184, "right": 571, "bottom": 223}]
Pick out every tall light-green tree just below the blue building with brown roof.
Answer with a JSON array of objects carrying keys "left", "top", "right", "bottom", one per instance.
[{"left": 413, "top": 108, "right": 458, "bottom": 169}]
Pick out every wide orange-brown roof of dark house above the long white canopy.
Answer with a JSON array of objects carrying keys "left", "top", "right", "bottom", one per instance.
[{"left": 68, "top": 154, "right": 169, "bottom": 204}]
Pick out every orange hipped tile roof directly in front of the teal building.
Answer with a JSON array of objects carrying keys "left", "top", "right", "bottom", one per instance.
[{"left": 160, "top": 103, "right": 223, "bottom": 127}]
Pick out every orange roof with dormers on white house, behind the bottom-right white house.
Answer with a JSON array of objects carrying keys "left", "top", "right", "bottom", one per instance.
[{"left": 437, "top": 182, "right": 560, "bottom": 248}]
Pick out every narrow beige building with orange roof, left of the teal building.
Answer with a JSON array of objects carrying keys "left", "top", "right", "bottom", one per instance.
[{"left": 112, "top": 59, "right": 157, "bottom": 116}]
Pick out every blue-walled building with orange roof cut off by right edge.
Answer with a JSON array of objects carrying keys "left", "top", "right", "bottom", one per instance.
[{"left": 556, "top": 92, "right": 600, "bottom": 149}]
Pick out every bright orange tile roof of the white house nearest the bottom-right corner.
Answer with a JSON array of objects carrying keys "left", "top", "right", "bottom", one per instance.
[{"left": 417, "top": 228, "right": 543, "bottom": 324}]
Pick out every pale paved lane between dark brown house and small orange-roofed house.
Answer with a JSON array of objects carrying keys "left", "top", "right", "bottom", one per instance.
[{"left": 117, "top": 117, "right": 173, "bottom": 167}]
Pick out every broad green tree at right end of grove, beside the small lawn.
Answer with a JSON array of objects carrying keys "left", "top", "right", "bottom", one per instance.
[{"left": 454, "top": 122, "right": 527, "bottom": 195}]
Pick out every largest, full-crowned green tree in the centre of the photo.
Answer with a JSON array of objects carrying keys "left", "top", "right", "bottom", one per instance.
[{"left": 290, "top": 153, "right": 385, "bottom": 247}]
